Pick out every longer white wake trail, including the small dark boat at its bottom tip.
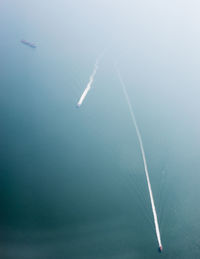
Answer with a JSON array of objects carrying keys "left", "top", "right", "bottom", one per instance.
[{"left": 116, "top": 67, "right": 163, "bottom": 252}]
